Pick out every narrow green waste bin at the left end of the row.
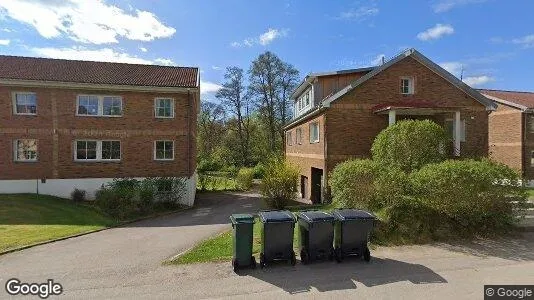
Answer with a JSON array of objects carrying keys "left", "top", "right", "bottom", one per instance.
[{"left": 230, "top": 214, "right": 256, "bottom": 272}]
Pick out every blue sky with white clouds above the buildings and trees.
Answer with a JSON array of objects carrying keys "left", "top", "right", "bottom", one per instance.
[{"left": 0, "top": 0, "right": 534, "bottom": 100}]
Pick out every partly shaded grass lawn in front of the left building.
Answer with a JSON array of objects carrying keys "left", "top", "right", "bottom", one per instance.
[{"left": 0, "top": 194, "right": 116, "bottom": 252}]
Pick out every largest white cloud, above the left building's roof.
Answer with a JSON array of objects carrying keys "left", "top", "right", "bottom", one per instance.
[{"left": 0, "top": 0, "right": 176, "bottom": 44}]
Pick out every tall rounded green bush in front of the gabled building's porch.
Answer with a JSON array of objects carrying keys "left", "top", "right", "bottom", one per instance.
[{"left": 371, "top": 120, "right": 451, "bottom": 172}]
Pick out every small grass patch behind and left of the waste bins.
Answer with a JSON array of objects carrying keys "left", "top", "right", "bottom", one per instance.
[{"left": 169, "top": 218, "right": 298, "bottom": 264}]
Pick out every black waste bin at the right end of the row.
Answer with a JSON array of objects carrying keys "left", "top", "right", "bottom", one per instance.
[{"left": 333, "top": 209, "right": 376, "bottom": 262}]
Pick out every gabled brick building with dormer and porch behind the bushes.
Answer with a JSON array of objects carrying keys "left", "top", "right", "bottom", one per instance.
[{"left": 285, "top": 49, "right": 496, "bottom": 203}]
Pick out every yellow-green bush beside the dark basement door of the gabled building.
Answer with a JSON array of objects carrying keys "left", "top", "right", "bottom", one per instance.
[{"left": 261, "top": 159, "right": 299, "bottom": 209}]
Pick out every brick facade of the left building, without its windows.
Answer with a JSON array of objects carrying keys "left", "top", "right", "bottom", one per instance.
[{"left": 0, "top": 86, "right": 199, "bottom": 179}]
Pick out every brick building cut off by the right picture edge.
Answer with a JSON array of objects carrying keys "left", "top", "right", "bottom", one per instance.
[{"left": 479, "top": 90, "right": 534, "bottom": 184}]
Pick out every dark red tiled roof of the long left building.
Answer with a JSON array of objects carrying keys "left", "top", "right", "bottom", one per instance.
[{"left": 0, "top": 55, "right": 198, "bottom": 88}]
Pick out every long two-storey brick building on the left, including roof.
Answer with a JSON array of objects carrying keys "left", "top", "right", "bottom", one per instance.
[{"left": 0, "top": 56, "right": 200, "bottom": 204}]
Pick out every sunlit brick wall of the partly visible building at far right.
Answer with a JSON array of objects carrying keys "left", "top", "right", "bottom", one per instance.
[{"left": 488, "top": 104, "right": 523, "bottom": 173}]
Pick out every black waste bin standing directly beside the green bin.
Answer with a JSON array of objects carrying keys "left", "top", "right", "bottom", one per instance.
[{"left": 258, "top": 211, "right": 296, "bottom": 268}]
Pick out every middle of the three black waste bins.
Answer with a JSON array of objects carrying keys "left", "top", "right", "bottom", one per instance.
[{"left": 297, "top": 211, "right": 334, "bottom": 264}]
